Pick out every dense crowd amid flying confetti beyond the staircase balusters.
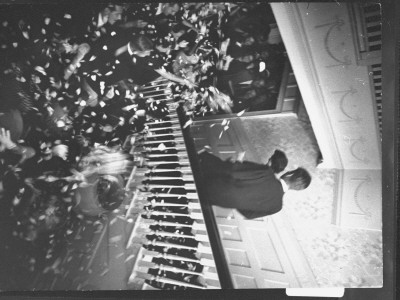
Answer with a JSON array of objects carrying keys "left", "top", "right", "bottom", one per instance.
[{"left": 0, "top": 2, "right": 284, "bottom": 290}]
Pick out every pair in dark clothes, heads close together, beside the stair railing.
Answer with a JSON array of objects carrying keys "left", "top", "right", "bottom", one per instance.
[{"left": 199, "top": 151, "right": 311, "bottom": 219}]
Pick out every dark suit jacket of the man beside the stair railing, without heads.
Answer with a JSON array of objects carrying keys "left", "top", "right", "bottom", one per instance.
[{"left": 200, "top": 152, "right": 284, "bottom": 219}]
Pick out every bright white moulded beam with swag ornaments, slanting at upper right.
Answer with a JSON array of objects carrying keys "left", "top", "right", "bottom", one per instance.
[{"left": 271, "top": 3, "right": 381, "bottom": 170}]
